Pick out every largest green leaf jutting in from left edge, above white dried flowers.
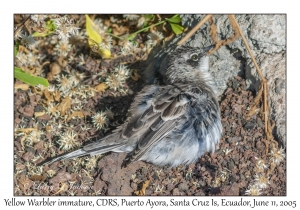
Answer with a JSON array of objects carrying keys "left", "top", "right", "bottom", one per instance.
[{"left": 14, "top": 67, "right": 49, "bottom": 87}]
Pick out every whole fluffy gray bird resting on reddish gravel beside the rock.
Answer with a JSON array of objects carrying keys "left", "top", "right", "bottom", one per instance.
[{"left": 39, "top": 46, "right": 222, "bottom": 167}]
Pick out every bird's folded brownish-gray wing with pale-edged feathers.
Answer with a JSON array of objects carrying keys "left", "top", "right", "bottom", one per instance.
[{"left": 122, "top": 85, "right": 192, "bottom": 163}]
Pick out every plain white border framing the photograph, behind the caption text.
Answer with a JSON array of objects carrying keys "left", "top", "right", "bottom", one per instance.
[{"left": 0, "top": 0, "right": 300, "bottom": 209}]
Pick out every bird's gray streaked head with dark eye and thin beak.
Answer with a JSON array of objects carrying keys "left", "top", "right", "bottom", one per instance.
[{"left": 166, "top": 45, "right": 214, "bottom": 84}]
